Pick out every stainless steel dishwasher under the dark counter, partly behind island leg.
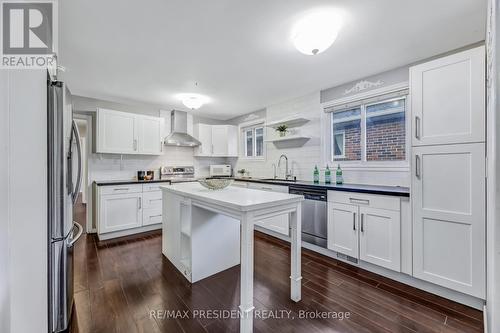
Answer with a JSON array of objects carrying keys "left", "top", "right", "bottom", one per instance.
[{"left": 288, "top": 186, "right": 327, "bottom": 248}]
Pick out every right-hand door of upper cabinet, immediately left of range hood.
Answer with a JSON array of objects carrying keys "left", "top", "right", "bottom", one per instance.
[{"left": 136, "top": 116, "right": 163, "bottom": 155}]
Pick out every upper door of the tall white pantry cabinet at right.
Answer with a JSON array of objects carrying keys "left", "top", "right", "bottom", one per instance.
[{"left": 410, "top": 46, "right": 485, "bottom": 146}]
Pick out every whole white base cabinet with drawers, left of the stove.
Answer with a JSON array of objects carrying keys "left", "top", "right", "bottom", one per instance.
[{"left": 96, "top": 183, "right": 166, "bottom": 239}]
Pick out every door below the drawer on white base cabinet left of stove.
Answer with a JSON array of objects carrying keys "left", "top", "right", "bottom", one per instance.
[{"left": 99, "top": 193, "right": 142, "bottom": 233}]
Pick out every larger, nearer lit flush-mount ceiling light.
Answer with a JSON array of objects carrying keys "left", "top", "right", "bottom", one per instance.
[{"left": 292, "top": 9, "right": 342, "bottom": 55}]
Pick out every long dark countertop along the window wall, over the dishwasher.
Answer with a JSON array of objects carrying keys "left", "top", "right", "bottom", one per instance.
[{"left": 235, "top": 178, "right": 410, "bottom": 197}]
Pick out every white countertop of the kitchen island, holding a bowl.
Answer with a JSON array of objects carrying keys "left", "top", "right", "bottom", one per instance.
[{"left": 161, "top": 182, "right": 304, "bottom": 212}]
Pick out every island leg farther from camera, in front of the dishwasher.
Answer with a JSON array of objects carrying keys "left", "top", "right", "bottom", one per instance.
[{"left": 290, "top": 203, "right": 302, "bottom": 302}]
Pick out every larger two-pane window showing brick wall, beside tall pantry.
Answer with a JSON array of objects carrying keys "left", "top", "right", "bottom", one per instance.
[{"left": 331, "top": 97, "right": 406, "bottom": 163}]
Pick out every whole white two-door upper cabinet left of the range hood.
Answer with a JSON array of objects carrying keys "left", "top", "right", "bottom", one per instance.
[{"left": 96, "top": 109, "right": 163, "bottom": 155}]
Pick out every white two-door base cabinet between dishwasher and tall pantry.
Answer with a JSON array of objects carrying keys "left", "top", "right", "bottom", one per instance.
[{"left": 327, "top": 191, "right": 401, "bottom": 272}]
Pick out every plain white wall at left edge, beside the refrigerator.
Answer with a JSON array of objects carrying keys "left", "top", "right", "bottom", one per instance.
[{"left": 0, "top": 70, "right": 48, "bottom": 332}]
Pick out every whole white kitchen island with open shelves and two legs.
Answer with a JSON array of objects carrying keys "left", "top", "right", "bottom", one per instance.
[{"left": 161, "top": 183, "right": 304, "bottom": 332}]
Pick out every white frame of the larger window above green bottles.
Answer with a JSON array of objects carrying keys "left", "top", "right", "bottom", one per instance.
[{"left": 324, "top": 93, "right": 411, "bottom": 171}]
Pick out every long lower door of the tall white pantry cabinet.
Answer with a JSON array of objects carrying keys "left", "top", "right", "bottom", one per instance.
[{"left": 412, "top": 143, "right": 486, "bottom": 299}]
